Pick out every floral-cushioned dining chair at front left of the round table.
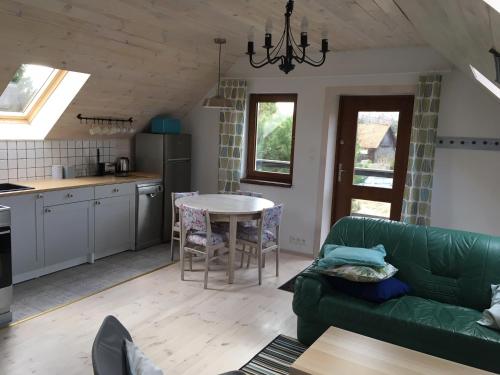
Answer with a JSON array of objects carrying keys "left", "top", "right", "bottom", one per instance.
[{"left": 180, "top": 205, "right": 228, "bottom": 289}]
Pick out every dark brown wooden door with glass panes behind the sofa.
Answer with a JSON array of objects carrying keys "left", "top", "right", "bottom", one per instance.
[{"left": 332, "top": 95, "right": 413, "bottom": 221}]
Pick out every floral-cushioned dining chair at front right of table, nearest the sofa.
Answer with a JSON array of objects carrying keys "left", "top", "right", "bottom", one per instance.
[{"left": 236, "top": 204, "right": 283, "bottom": 285}]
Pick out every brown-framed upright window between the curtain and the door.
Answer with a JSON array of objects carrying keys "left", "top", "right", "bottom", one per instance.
[{"left": 243, "top": 94, "right": 297, "bottom": 185}]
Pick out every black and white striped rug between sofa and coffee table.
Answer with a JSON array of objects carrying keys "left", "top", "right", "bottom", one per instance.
[{"left": 240, "top": 335, "right": 307, "bottom": 375}]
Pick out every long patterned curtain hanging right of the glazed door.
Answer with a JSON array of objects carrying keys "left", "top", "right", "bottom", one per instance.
[{"left": 401, "top": 74, "right": 441, "bottom": 225}]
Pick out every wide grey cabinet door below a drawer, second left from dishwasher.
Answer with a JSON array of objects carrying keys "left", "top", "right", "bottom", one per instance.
[{"left": 43, "top": 201, "right": 94, "bottom": 273}]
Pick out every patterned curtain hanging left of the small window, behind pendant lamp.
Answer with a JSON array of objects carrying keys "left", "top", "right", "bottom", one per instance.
[{"left": 218, "top": 79, "right": 247, "bottom": 192}]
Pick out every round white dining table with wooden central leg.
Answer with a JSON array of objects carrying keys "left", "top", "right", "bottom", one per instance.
[{"left": 175, "top": 194, "right": 274, "bottom": 284}]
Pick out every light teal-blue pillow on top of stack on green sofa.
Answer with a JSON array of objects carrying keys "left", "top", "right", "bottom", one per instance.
[{"left": 318, "top": 245, "right": 387, "bottom": 269}]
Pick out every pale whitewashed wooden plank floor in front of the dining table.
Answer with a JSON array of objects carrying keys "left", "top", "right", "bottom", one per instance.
[{"left": 0, "top": 253, "right": 311, "bottom": 375}]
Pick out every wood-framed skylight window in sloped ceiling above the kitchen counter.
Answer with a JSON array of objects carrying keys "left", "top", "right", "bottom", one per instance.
[{"left": 0, "top": 64, "right": 66, "bottom": 122}]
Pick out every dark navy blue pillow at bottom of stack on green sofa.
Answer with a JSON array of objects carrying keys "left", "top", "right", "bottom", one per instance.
[{"left": 329, "top": 277, "right": 410, "bottom": 303}]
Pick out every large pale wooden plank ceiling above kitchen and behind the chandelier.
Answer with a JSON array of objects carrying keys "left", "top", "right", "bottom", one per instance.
[{"left": 0, "top": 0, "right": 424, "bottom": 138}]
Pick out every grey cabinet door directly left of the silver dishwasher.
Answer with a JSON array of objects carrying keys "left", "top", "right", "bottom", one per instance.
[{"left": 94, "top": 194, "right": 135, "bottom": 259}]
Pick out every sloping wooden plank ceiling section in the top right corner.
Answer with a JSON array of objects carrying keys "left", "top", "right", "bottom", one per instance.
[{"left": 395, "top": 0, "right": 500, "bottom": 95}]
